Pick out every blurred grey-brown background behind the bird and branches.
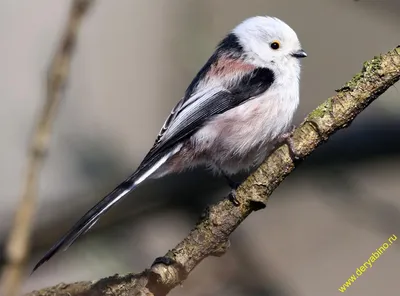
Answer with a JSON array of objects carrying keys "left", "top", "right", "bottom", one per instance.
[{"left": 0, "top": 0, "right": 400, "bottom": 296}]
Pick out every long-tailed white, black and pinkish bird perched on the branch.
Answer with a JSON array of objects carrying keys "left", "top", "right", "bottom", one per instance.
[{"left": 32, "top": 16, "right": 307, "bottom": 272}]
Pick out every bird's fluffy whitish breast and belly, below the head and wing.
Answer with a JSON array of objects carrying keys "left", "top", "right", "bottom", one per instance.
[{"left": 192, "top": 77, "right": 299, "bottom": 173}]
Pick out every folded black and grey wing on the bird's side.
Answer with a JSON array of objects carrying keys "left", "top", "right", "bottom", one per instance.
[{"left": 140, "top": 68, "right": 274, "bottom": 167}]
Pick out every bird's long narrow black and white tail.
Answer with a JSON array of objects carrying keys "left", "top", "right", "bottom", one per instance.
[{"left": 32, "top": 149, "right": 178, "bottom": 273}]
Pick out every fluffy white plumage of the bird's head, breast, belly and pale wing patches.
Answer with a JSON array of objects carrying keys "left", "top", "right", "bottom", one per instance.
[{"left": 158, "top": 16, "right": 301, "bottom": 176}]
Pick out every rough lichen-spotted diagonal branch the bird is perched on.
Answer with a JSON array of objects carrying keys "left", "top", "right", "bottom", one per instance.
[{"left": 26, "top": 45, "right": 400, "bottom": 296}]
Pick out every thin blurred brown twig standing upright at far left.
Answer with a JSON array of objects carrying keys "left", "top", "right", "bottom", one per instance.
[{"left": 0, "top": 0, "right": 93, "bottom": 296}]
